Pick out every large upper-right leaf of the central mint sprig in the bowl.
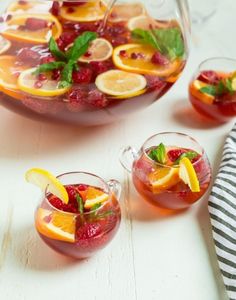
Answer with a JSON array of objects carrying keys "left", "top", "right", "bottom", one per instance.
[{"left": 66, "top": 31, "right": 97, "bottom": 62}]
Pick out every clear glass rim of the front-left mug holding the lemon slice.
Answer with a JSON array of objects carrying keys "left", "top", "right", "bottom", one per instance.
[{"left": 43, "top": 171, "right": 111, "bottom": 216}]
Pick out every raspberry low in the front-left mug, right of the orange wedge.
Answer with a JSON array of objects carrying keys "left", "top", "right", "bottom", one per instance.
[{"left": 76, "top": 222, "right": 102, "bottom": 240}]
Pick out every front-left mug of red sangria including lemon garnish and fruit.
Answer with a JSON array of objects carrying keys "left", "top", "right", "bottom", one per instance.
[{"left": 27, "top": 169, "right": 121, "bottom": 259}]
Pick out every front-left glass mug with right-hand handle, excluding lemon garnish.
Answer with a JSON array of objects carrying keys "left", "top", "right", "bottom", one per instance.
[{"left": 35, "top": 172, "right": 121, "bottom": 259}]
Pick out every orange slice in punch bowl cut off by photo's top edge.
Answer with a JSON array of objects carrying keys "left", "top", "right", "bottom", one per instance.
[{"left": 60, "top": 1, "right": 106, "bottom": 22}]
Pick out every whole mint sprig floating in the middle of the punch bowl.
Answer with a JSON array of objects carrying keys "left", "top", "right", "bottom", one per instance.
[{"left": 35, "top": 31, "right": 97, "bottom": 88}]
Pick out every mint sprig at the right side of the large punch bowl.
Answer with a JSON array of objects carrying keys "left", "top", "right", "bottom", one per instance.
[{"left": 132, "top": 27, "right": 184, "bottom": 60}]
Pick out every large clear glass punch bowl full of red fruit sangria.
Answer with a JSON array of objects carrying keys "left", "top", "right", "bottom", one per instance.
[{"left": 0, "top": 0, "right": 189, "bottom": 125}]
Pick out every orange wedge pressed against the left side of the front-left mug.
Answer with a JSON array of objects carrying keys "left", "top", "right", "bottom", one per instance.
[{"left": 35, "top": 208, "right": 76, "bottom": 243}]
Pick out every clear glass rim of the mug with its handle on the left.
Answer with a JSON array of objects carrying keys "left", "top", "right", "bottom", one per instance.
[{"left": 141, "top": 131, "right": 205, "bottom": 169}]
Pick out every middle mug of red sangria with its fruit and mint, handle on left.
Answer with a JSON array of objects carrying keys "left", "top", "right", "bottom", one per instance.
[{"left": 123, "top": 132, "right": 211, "bottom": 211}]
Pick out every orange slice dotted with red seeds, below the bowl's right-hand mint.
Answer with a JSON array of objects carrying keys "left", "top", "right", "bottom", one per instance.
[{"left": 112, "top": 44, "right": 181, "bottom": 77}]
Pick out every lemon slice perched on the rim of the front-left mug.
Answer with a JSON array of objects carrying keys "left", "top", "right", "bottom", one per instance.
[{"left": 25, "top": 168, "right": 69, "bottom": 203}]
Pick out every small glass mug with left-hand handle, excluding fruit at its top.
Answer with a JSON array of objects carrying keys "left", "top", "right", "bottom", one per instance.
[{"left": 120, "top": 132, "right": 211, "bottom": 211}]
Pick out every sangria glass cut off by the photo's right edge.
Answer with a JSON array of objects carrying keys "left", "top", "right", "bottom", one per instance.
[{"left": 189, "top": 58, "right": 236, "bottom": 122}]
